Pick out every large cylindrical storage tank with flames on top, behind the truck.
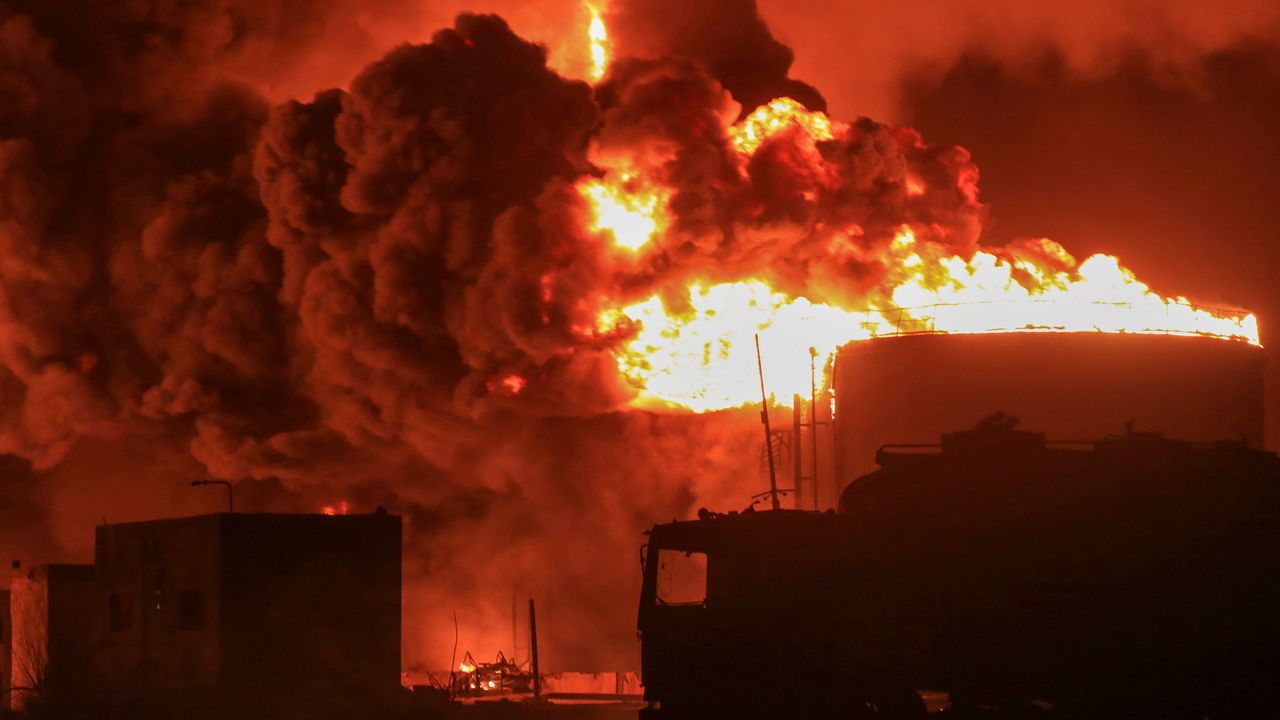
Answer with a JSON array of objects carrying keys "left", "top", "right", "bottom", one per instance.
[{"left": 833, "top": 332, "right": 1265, "bottom": 488}]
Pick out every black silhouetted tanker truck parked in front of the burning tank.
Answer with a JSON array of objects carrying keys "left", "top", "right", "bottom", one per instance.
[{"left": 639, "top": 419, "right": 1280, "bottom": 719}]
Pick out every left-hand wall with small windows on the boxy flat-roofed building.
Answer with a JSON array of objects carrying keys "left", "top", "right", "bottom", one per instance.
[{"left": 95, "top": 515, "right": 220, "bottom": 688}]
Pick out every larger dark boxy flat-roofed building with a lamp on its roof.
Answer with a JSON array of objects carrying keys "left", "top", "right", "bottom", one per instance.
[{"left": 95, "top": 512, "right": 401, "bottom": 698}]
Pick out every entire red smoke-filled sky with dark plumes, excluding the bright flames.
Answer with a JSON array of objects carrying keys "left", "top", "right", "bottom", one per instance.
[{"left": 0, "top": 0, "right": 1280, "bottom": 670}]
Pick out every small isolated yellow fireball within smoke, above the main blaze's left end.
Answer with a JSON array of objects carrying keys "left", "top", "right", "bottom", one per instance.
[{"left": 579, "top": 172, "right": 666, "bottom": 251}]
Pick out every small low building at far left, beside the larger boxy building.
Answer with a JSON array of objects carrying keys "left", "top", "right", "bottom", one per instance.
[{"left": 8, "top": 565, "right": 97, "bottom": 708}]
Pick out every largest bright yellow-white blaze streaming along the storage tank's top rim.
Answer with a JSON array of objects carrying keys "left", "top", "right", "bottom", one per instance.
[{"left": 600, "top": 228, "right": 1258, "bottom": 413}]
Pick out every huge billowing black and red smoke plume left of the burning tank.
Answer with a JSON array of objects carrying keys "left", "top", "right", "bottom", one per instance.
[{"left": 0, "top": 0, "right": 1269, "bottom": 669}]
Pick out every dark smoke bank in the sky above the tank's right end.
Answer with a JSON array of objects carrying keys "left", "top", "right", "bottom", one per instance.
[{"left": 902, "top": 41, "right": 1280, "bottom": 447}]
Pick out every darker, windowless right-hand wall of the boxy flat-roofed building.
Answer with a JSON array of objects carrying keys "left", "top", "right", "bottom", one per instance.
[{"left": 221, "top": 515, "right": 401, "bottom": 697}]
